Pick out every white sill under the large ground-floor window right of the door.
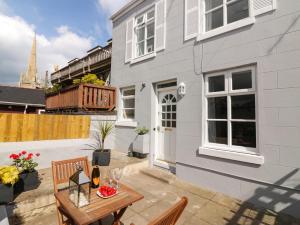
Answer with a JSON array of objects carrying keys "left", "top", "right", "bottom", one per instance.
[{"left": 198, "top": 147, "right": 264, "bottom": 165}]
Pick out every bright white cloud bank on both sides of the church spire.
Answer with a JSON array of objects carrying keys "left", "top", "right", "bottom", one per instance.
[{"left": 0, "top": 13, "right": 93, "bottom": 83}]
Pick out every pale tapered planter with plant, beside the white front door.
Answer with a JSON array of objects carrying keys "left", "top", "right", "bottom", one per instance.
[{"left": 133, "top": 127, "right": 150, "bottom": 158}]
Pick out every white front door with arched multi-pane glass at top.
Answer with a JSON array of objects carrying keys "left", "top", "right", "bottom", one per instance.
[{"left": 155, "top": 90, "right": 177, "bottom": 168}]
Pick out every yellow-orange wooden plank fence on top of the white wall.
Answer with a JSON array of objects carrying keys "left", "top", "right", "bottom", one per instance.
[{"left": 0, "top": 113, "right": 90, "bottom": 142}]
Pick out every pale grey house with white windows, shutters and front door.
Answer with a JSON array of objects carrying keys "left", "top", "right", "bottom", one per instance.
[{"left": 111, "top": 0, "right": 300, "bottom": 217}]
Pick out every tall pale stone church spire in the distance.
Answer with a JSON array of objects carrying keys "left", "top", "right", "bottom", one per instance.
[{"left": 20, "top": 33, "right": 38, "bottom": 88}]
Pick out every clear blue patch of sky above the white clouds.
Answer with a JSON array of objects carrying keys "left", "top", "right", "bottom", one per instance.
[{"left": 7, "top": 0, "right": 111, "bottom": 45}]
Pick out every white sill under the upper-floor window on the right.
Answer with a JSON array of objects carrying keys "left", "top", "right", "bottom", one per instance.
[{"left": 197, "top": 17, "right": 255, "bottom": 41}]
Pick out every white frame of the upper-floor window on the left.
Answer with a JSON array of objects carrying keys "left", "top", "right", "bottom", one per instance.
[{"left": 133, "top": 6, "right": 156, "bottom": 59}]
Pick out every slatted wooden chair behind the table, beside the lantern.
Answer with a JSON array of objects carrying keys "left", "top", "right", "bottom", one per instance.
[{"left": 52, "top": 157, "right": 90, "bottom": 225}]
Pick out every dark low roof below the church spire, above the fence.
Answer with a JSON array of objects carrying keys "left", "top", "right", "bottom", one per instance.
[{"left": 0, "top": 86, "right": 45, "bottom": 105}]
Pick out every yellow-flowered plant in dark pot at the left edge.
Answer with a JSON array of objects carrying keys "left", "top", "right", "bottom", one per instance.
[{"left": 0, "top": 166, "right": 19, "bottom": 204}]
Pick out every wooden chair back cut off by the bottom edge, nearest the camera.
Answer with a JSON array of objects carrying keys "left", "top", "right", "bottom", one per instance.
[{"left": 131, "top": 197, "right": 188, "bottom": 225}]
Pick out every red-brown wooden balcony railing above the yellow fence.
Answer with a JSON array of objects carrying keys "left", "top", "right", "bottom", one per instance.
[{"left": 46, "top": 84, "right": 116, "bottom": 111}]
